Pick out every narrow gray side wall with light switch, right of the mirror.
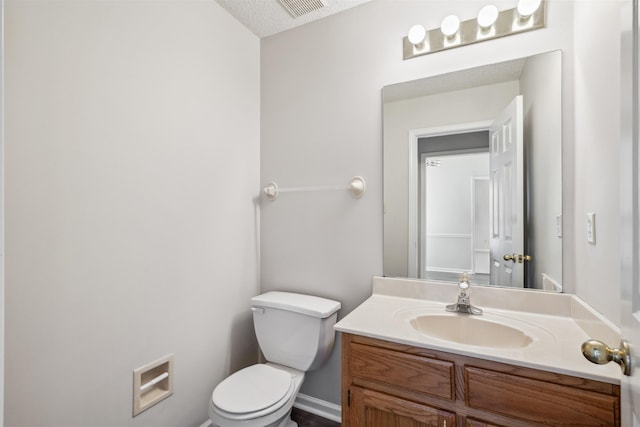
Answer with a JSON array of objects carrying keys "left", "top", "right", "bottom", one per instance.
[{"left": 564, "top": 0, "right": 623, "bottom": 325}]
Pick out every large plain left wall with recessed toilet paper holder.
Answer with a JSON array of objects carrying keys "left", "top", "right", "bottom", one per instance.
[{"left": 4, "top": 1, "right": 260, "bottom": 427}]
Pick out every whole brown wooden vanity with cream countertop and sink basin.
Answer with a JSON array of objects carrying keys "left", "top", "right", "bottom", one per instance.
[{"left": 336, "top": 277, "right": 621, "bottom": 427}]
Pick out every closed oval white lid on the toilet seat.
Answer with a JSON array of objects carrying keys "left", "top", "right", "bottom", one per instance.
[{"left": 212, "top": 364, "right": 293, "bottom": 414}]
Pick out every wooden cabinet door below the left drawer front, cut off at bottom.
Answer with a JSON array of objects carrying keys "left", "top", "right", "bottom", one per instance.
[{"left": 349, "top": 387, "right": 456, "bottom": 427}]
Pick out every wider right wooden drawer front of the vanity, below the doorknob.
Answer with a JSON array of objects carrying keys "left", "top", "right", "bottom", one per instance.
[{"left": 465, "top": 366, "right": 620, "bottom": 426}]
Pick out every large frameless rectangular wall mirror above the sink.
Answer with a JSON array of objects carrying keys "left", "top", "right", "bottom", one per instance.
[{"left": 383, "top": 51, "right": 562, "bottom": 292}]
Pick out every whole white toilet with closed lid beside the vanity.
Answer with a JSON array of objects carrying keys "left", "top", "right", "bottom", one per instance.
[{"left": 209, "top": 292, "right": 340, "bottom": 427}]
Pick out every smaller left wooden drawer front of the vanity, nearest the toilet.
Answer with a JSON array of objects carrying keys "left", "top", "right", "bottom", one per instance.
[{"left": 349, "top": 343, "right": 455, "bottom": 400}]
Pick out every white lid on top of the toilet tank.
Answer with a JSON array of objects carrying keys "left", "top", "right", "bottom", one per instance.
[{"left": 251, "top": 291, "right": 340, "bottom": 319}]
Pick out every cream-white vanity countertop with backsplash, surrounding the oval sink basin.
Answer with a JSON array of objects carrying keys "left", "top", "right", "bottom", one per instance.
[{"left": 335, "top": 277, "right": 621, "bottom": 384}]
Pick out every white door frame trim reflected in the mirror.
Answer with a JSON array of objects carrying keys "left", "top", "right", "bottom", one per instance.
[{"left": 407, "top": 120, "right": 493, "bottom": 278}]
